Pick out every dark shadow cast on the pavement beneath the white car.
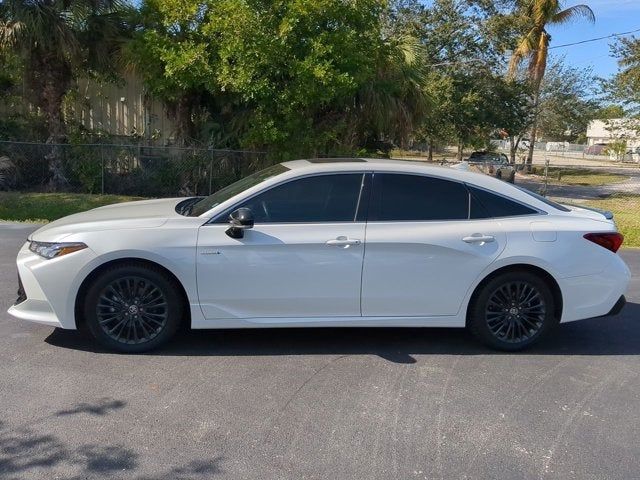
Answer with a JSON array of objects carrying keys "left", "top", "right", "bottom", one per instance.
[{"left": 45, "top": 303, "right": 640, "bottom": 364}]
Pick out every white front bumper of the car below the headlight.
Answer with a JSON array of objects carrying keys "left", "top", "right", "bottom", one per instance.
[{"left": 8, "top": 242, "right": 96, "bottom": 329}]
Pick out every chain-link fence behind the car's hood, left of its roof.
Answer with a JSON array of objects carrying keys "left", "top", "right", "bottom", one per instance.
[{"left": 0, "top": 141, "right": 268, "bottom": 197}]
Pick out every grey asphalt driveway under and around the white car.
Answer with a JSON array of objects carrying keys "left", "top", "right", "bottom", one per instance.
[{"left": 0, "top": 225, "right": 640, "bottom": 480}]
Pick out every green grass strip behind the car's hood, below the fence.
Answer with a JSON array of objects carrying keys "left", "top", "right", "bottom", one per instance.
[{"left": 0, "top": 192, "right": 142, "bottom": 223}]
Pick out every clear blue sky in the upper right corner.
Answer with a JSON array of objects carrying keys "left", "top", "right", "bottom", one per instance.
[{"left": 549, "top": 0, "right": 640, "bottom": 77}]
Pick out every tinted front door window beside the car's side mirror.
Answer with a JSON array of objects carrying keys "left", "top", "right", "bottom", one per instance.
[{"left": 235, "top": 173, "right": 363, "bottom": 223}]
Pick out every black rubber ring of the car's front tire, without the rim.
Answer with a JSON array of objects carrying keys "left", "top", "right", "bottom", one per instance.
[{"left": 83, "top": 264, "right": 183, "bottom": 353}]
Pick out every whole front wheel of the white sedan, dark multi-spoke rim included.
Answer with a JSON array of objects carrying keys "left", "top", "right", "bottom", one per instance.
[{"left": 83, "top": 263, "right": 184, "bottom": 353}]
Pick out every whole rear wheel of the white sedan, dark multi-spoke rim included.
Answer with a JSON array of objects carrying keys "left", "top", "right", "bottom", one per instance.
[{"left": 467, "top": 270, "right": 558, "bottom": 351}]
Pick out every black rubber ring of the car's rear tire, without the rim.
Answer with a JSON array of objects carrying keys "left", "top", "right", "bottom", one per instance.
[{"left": 468, "top": 271, "right": 558, "bottom": 351}]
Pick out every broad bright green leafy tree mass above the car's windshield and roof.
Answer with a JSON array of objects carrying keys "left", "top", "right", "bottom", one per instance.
[{"left": 129, "top": 0, "right": 426, "bottom": 158}]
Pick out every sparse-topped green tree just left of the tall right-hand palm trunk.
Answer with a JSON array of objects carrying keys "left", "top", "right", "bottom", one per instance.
[{"left": 419, "top": 0, "right": 529, "bottom": 158}]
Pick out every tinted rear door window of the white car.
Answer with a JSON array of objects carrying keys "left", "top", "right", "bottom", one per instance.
[{"left": 370, "top": 173, "right": 469, "bottom": 221}]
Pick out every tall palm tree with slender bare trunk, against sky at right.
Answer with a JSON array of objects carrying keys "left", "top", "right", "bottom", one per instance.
[{"left": 508, "top": 0, "right": 595, "bottom": 164}]
